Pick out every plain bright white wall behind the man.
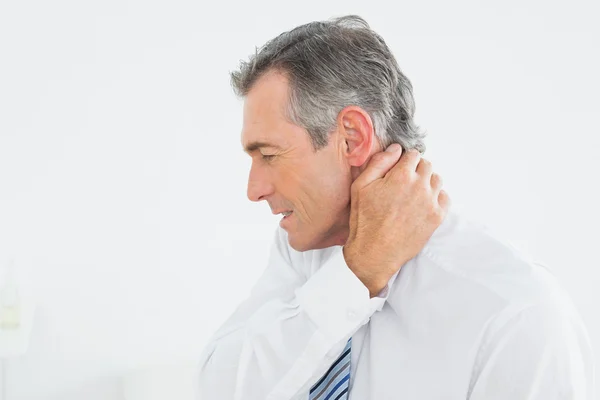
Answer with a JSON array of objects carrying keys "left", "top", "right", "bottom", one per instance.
[{"left": 0, "top": 0, "right": 600, "bottom": 400}]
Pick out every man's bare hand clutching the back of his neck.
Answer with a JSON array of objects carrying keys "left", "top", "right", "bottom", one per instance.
[{"left": 343, "top": 144, "right": 450, "bottom": 297}]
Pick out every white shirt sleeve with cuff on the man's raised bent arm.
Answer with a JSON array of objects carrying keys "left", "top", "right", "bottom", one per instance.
[{"left": 200, "top": 229, "right": 388, "bottom": 400}]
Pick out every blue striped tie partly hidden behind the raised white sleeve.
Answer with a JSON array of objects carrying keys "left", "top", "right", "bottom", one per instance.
[{"left": 308, "top": 338, "right": 352, "bottom": 400}]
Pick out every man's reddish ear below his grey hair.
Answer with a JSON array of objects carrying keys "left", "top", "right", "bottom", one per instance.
[{"left": 337, "top": 106, "right": 375, "bottom": 167}]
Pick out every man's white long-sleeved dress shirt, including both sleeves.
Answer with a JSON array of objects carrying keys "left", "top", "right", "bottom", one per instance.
[{"left": 200, "top": 211, "right": 594, "bottom": 400}]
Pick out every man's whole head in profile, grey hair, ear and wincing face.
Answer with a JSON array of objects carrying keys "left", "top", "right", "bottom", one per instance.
[{"left": 231, "top": 15, "right": 425, "bottom": 251}]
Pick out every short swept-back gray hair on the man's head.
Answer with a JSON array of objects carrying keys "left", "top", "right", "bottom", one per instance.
[{"left": 231, "top": 15, "right": 426, "bottom": 153}]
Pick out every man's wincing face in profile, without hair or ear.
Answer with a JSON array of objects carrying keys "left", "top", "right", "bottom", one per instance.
[{"left": 242, "top": 72, "right": 352, "bottom": 251}]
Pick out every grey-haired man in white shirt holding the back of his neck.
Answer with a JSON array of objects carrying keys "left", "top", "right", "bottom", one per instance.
[{"left": 200, "top": 16, "right": 594, "bottom": 400}]
